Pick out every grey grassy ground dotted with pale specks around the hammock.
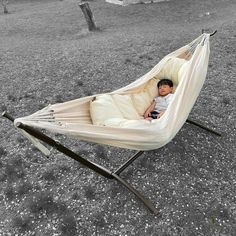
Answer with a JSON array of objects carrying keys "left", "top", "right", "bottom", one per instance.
[{"left": 0, "top": 0, "right": 236, "bottom": 236}]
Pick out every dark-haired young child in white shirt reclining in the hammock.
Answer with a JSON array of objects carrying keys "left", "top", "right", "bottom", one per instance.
[{"left": 144, "top": 79, "right": 173, "bottom": 120}]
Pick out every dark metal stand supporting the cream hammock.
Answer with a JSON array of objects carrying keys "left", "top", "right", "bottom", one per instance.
[{"left": 2, "top": 112, "right": 221, "bottom": 214}]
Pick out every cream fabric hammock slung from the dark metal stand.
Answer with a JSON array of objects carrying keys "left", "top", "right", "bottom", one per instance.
[{"left": 15, "top": 33, "right": 210, "bottom": 152}]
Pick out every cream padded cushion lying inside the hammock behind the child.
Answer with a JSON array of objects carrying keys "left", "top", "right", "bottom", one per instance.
[{"left": 90, "top": 58, "right": 186, "bottom": 126}]
